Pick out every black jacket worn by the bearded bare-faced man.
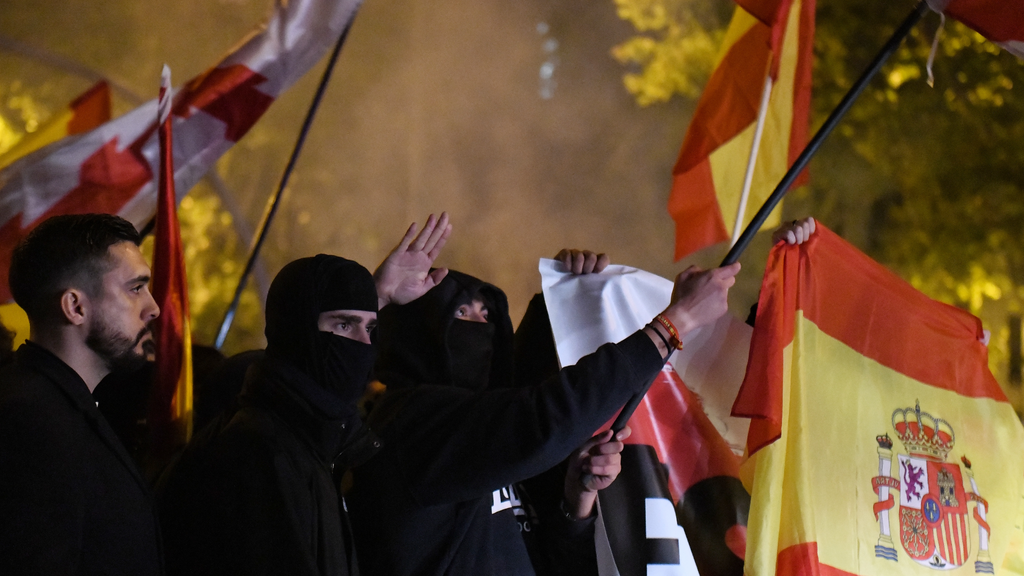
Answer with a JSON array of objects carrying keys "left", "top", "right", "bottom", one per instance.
[{"left": 0, "top": 342, "right": 162, "bottom": 576}]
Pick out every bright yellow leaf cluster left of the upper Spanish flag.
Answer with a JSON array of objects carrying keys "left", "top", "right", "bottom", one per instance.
[{"left": 611, "top": 0, "right": 720, "bottom": 106}]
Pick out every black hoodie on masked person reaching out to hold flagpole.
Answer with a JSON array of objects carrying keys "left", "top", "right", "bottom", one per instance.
[{"left": 347, "top": 272, "right": 664, "bottom": 576}]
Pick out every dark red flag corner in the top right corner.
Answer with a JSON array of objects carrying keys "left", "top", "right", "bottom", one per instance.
[{"left": 928, "top": 0, "right": 1024, "bottom": 58}]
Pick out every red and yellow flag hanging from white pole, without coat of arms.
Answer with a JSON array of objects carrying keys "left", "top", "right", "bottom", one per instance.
[{"left": 669, "top": 0, "right": 815, "bottom": 259}]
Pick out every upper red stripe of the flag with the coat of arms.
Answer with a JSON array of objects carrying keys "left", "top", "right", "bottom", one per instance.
[{"left": 732, "top": 223, "right": 1007, "bottom": 454}]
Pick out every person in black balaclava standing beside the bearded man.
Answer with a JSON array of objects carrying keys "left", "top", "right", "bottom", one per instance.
[{"left": 158, "top": 254, "right": 380, "bottom": 575}]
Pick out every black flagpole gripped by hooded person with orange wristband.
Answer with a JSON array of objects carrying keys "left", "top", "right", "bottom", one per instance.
[{"left": 611, "top": 0, "right": 928, "bottom": 431}]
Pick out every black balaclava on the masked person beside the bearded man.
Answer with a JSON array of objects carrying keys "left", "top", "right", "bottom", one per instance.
[{"left": 265, "top": 254, "right": 377, "bottom": 413}]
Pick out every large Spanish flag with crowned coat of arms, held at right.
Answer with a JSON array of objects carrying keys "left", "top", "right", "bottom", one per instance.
[{"left": 733, "top": 224, "right": 1024, "bottom": 576}]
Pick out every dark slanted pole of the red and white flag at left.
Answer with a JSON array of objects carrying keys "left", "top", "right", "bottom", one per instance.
[{"left": 213, "top": 22, "right": 352, "bottom": 351}]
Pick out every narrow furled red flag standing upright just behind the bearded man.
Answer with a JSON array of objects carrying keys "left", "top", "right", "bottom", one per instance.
[{"left": 148, "top": 66, "right": 193, "bottom": 446}]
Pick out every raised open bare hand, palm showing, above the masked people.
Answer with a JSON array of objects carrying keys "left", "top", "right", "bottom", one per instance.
[{"left": 374, "top": 212, "right": 452, "bottom": 308}]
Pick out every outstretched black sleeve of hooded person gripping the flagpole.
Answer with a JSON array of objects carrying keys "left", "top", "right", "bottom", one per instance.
[{"left": 371, "top": 332, "right": 665, "bottom": 505}]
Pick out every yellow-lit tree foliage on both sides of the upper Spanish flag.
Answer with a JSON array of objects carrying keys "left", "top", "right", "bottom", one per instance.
[{"left": 615, "top": 0, "right": 1024, "bottom": 381}]
